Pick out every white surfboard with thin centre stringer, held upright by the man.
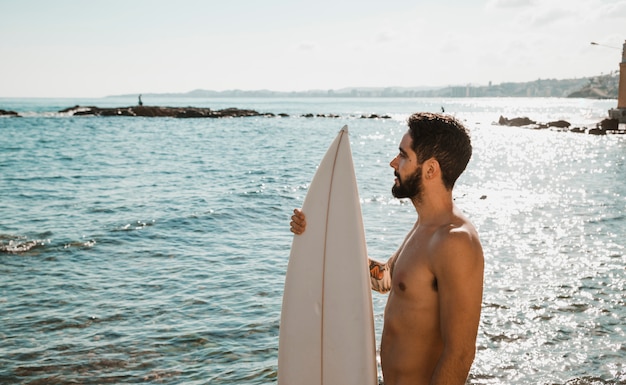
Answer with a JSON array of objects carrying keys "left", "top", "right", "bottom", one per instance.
[{"left": 278, "top": 126, "right": 378, "bottom": 385}]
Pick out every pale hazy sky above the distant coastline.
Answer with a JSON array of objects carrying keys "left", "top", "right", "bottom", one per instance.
[{"left": 0, "top": 0, "right": 626, "bottom": 97}]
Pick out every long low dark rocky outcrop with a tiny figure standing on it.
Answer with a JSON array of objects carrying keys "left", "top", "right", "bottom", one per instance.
[{"left": 59, "top": 106, "right": 274, "bottom": 118}]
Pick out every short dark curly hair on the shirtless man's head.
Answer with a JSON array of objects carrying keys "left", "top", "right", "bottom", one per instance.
[{"left": 408, "top": 112, "right": 472, "bottom": 190}]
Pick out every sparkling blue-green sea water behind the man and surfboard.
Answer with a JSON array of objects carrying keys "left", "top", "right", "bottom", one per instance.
[{"left": 0, "top": 97, "right": 626, "bottom": 385}]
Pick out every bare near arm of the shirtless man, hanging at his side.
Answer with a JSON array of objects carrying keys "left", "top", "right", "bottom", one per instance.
[{"left": 431, "top": 230, "right": 484, "bottom": 385}]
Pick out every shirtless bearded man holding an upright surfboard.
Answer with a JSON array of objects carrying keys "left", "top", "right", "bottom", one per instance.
[{"left": 291, "top": 113, "right": 484, "bottom": 385}]
